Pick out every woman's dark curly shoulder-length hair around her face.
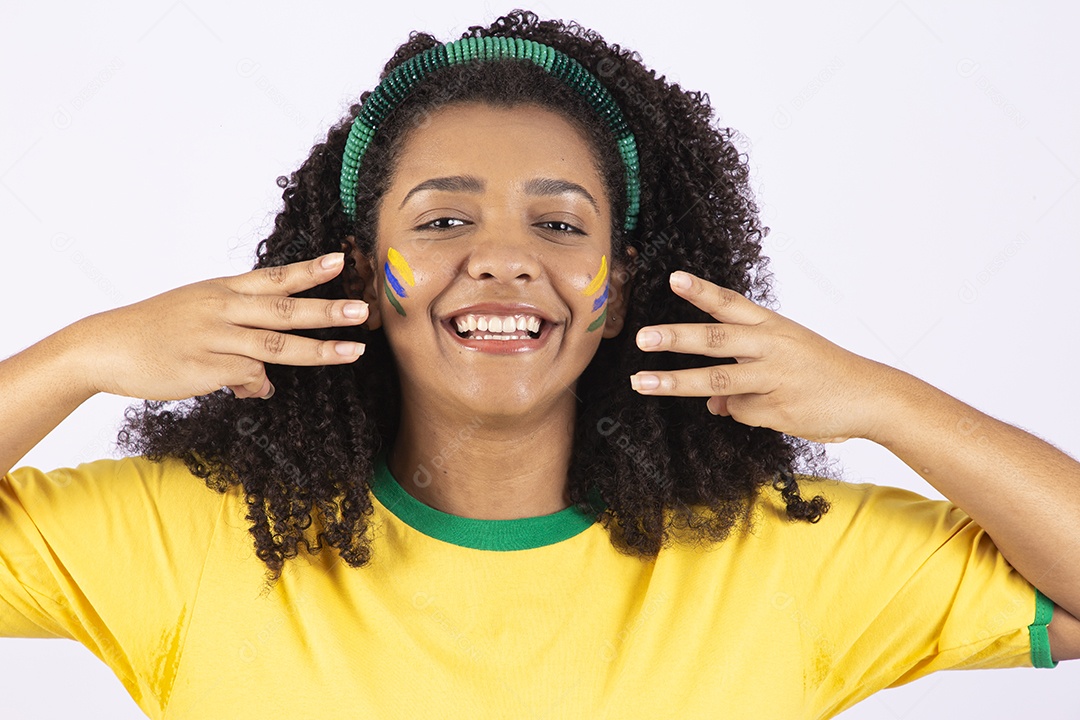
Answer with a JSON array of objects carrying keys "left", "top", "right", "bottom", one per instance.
[{"left": 119, "top": 10, "right": 828, "bottom": 586}]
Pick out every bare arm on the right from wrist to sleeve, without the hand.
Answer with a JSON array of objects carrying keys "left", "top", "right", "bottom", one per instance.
[{"left": 869, "top": 366, "right": 1080, "bottom": 660}]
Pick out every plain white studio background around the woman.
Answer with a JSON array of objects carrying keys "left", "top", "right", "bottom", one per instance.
[{"left": 0, "top": 0, "right": 1080, "bottom": 720}]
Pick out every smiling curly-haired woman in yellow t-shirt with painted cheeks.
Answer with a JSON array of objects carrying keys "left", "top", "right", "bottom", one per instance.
[{"left": 0, "top": 8, "right": 1080, "bottom": 717}]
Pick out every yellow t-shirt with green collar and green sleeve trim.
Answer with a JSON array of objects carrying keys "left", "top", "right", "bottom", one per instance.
[{"left": 0, "top": 458, "right": 1053, "bottom": 720}]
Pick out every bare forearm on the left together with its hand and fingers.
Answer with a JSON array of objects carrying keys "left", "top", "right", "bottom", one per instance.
[{"left": 0, "top": 253, "right": 367, "bottom": 474}]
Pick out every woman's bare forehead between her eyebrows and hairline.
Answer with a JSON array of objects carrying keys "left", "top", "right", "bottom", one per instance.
[{"left": 394, "top": 103, "right": 603, "bottom": 192}]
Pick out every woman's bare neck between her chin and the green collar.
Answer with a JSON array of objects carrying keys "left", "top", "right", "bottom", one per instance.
[{"left": 387, "top": 393, "right": 577, "bottom": 520}]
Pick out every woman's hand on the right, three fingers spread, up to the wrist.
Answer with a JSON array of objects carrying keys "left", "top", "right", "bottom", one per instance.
[{"left": 631, "top": 272, "right": 900, "bottom": 443}]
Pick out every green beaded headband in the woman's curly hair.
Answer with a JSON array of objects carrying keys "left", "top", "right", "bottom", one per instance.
[{"left": 341, "top": 38, "right": 640, "bottom": 230}]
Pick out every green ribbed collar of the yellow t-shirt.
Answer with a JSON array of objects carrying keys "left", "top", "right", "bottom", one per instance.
[{"left": 372, "top": 452, "right": 606, "bottom": 551}]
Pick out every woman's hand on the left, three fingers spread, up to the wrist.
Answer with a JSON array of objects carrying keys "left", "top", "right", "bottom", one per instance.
[{"left": 67, "top": 253, "right": 367, "bottom": 400}]
